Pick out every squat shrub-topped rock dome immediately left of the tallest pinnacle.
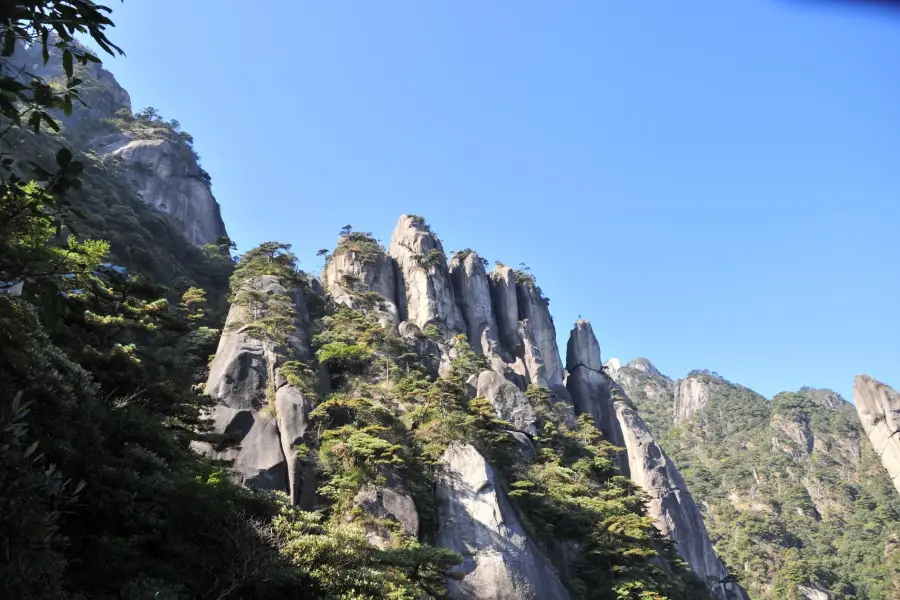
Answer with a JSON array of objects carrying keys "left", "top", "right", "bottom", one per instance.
[{"left": 322, "top": 246, "right": 400, "bottom": 326}]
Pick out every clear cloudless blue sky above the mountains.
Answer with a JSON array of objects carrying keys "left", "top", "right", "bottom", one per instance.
[{"left": 82, "top": 0, "right": 900, "bottom": 399}]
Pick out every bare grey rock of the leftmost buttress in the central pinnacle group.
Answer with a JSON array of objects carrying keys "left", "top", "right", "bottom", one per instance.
[{"left": 196, "top": 275, "right": 314, "bottom": 504}]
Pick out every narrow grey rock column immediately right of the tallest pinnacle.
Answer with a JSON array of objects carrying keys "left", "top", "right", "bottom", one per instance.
[{"left": 450, "top": 252, "right": 506, "bottom": 356}]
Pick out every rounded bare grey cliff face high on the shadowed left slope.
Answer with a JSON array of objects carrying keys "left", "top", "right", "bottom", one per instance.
[{"left": 94, "top": 128, "right": 226, "bottom": 245}]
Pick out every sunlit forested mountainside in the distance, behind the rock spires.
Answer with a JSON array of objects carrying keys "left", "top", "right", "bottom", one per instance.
[{"left": 625, "top": 368, "right": 900, "bottom": 600}]
